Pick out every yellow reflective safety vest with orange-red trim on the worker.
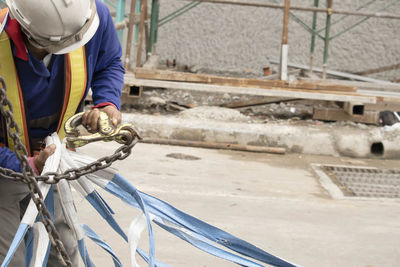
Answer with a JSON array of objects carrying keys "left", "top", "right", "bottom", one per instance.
[{"left": 0, "top": 9, "right": 87, "bottom": 156}]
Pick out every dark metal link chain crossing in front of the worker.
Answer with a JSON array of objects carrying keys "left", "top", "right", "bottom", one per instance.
[{"left": 0, "top": 76, "right": 139, "bottom": 266}]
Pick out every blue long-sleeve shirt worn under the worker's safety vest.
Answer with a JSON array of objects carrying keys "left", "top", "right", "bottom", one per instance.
[{"left": 0, "top": 0, "right": 125, "bottom": 171}]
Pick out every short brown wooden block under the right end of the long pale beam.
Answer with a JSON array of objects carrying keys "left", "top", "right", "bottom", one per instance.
[{"left": 313, "top": 108, "right": 379, "bottom": 124}]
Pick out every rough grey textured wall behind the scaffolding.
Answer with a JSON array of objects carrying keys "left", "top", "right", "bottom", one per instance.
[{"left": 138, "top": 0, "right": 400, "bottom": 80}]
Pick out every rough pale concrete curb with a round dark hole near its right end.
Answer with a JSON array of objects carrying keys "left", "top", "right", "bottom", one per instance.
[{"left": 123, "top": 111, "right": 400, "bottom": 158}]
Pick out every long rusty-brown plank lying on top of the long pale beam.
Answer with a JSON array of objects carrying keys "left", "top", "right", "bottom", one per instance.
[{"left": 134, "top": 68, "right": 357, "bottom": 92}]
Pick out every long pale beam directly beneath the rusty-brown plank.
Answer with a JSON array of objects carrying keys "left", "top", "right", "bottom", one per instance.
[{"left": 125, "top": 73, "right": 376, "bottom": 103}]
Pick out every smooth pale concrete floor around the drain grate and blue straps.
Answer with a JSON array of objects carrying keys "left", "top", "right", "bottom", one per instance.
[{"left": 76, "top": 143, "right": 400, "bottom": 267}]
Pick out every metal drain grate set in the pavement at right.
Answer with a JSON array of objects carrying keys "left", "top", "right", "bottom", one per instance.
[{"left": 320, "top": 165, "right": 400, "bottom": 198}]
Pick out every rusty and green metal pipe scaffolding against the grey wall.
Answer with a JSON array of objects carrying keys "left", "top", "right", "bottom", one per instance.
[{"left": 125, "top": 0, "right": 400, "bottom": 80}]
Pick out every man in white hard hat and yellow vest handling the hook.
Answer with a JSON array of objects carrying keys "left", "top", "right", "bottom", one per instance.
[{"left": 0, "top": 0, "right": 124, "bottom": 266}]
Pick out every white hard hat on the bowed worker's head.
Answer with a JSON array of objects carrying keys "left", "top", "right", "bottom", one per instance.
[{"left": 6, "top": 0, "right": 99, "bottom": 54}]
